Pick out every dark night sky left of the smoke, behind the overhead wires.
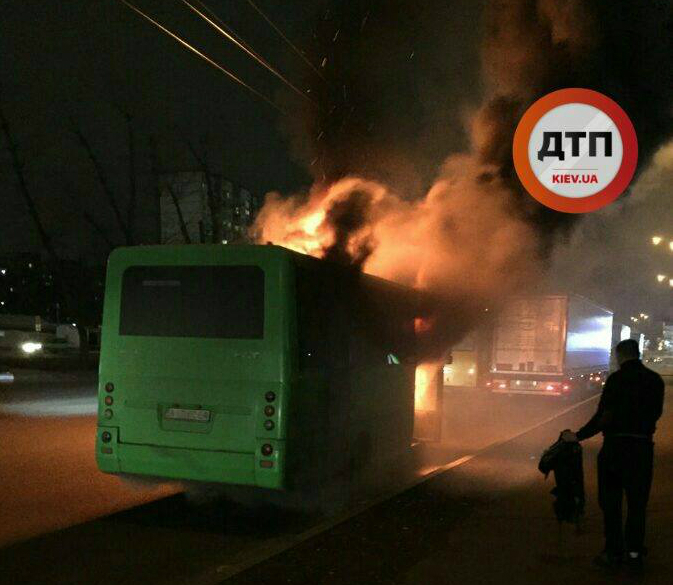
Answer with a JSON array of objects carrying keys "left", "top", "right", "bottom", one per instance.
[{"left": 0, "top": 0, "right": 330, "bottom": 256}]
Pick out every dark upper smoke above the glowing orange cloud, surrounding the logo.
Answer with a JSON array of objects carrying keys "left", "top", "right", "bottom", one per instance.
[{"left": 300, "top": 0, "right": 673, "bottom": 248}]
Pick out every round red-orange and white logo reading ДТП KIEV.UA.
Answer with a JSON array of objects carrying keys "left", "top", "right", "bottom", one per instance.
[{"left": 513, "top": 88, "right": 638, "bottom": 213}]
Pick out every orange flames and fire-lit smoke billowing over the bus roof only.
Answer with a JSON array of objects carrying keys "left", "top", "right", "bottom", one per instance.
[{"left": 253, "top": 155, "right": 536, "bottom": 296}]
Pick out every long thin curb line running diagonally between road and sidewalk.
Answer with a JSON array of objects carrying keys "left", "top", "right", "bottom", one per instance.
[{"left": 211, "top": 394, "right": 600, "bottom": 583}]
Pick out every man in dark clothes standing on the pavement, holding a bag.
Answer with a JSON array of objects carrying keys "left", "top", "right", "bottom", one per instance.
[{"left": 561, "top": 339, "right": 664, "bottom": 569}]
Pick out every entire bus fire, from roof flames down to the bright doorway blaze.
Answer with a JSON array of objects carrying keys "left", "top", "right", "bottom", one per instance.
[{"left": 252, "top": 51, "right": 539, "bottom": 388}]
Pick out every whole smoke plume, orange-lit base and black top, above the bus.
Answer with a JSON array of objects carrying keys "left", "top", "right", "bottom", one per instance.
[{"left": 255, "top": 0, "right": 671, "bottom": 352}]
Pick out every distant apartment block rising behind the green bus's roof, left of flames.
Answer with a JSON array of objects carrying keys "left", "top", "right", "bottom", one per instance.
[{"left": 159, "top": 171, "right": 262, "bottom": 244}]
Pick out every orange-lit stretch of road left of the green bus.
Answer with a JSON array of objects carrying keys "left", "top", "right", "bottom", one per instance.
[{"left": 0, "top": 370, "right": 179, "bottom": 546}]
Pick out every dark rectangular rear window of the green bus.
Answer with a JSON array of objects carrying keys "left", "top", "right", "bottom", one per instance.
[{"left": 119, "top": 266, "right": 264, "bottom": 339}]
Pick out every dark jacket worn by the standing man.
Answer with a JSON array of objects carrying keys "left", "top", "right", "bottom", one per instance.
[{"left": 577, "top": 360, "right": 664, "bottom": 441}]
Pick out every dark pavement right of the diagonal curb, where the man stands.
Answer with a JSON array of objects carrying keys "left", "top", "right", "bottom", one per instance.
[{"left": 222, "top": 386, "right": 673, "bottom": 585}]
